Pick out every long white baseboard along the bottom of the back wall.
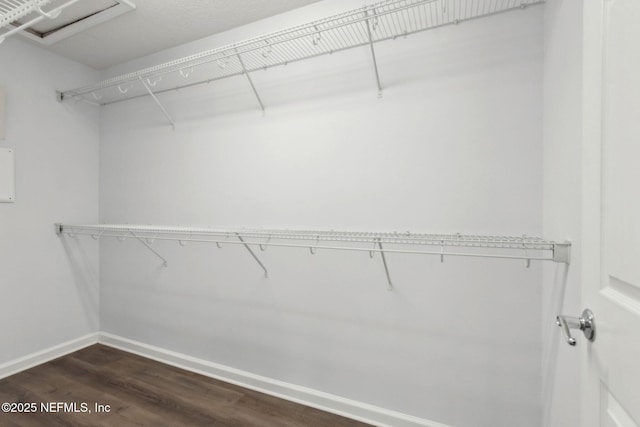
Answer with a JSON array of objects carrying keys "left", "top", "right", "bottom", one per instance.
[{"left": 98, "top": 332, "right": 449, "bottom": 427}]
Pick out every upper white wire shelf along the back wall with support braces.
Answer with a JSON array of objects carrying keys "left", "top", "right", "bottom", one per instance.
[{"left": 58, "top": 0, "right": 545, "bottom": 124}]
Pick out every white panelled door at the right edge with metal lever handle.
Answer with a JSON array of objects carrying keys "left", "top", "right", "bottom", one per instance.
[{"left": 584, "top": 0, "right": 640, "bottom": 427}]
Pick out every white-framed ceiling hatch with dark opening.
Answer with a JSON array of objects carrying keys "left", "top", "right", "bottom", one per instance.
[{"left": 12, "top": 0, "right": 136, "bottom": 46}]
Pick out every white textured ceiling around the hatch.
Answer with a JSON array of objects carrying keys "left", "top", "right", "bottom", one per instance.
[{"left": 43, "top": 0, "right": 318, "bottom": 70}]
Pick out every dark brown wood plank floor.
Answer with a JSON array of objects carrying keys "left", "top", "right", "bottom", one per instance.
[{"left": 0, "top": 345, "right": 366, "bottom": 427}]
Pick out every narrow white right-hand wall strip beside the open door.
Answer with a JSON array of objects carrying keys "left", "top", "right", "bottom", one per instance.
[{"left": 542, "top": 0, "right": 583, "bottom": 427}]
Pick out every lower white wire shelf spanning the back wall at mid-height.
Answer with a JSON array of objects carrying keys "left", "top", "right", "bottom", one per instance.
[{"left": 55, "top": 223, "right": 571, "bottom": 288}]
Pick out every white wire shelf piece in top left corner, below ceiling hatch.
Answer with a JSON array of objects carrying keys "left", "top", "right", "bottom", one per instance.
[{"left": 0, "top": 0, "right": 80, "bottom": 43}]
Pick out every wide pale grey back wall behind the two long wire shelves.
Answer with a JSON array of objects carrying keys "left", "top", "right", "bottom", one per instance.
[{"left": 96, "top": 0, "right": 543, "bottom": 427}]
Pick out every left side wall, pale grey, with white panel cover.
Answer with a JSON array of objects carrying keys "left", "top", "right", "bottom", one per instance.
[{"left": 0, "top": 37, "right": 99, "bottom": 364}]
